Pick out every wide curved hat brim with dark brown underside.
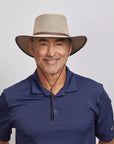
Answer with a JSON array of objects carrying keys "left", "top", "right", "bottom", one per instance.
[{"left": 15, "top": 35, "right": 87, "bottom": 57}]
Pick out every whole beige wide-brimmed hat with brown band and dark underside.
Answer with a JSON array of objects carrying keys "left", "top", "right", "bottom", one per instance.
[{"left": 15, "top": 14, "right": 87, "bottom": 57}]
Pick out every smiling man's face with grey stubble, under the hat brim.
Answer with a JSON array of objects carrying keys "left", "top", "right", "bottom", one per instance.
[{"left": 30, "top": 38, "right": 71, "bottom": 74}]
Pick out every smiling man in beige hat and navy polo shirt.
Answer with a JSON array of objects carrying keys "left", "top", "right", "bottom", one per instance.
[{"left": 0, "top": 14, "right": 114, "bottom": 144}]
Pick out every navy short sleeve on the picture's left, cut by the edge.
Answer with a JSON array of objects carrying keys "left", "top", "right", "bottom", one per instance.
[{"left": 0, "top": 93, "right": 12, "bottom": 142}]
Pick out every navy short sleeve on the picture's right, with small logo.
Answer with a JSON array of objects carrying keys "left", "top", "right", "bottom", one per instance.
[{"left": 95, "top": 87, "right": 114, "bottom": 142}]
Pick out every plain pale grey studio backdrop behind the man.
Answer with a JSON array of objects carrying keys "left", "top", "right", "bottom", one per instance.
[{"left": 0, "top": 0, "right": 114, "bottom": 144}]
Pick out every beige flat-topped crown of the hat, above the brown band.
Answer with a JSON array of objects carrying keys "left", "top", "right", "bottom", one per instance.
[{"left": 33, "top": 14, "right": 69, "bottom": 35}]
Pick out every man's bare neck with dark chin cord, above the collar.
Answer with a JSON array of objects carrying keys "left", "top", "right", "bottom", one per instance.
[{"left": 37, "top": 66, "right": 66, "bottom": 94}]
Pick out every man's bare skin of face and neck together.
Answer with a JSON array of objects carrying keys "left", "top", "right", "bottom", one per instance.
[{"left": 30, "top": 38, "right": 72, "bottom": 94}]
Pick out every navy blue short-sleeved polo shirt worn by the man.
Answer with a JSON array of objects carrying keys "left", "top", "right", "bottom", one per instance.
[{"left": 0, "top": 68, "right": 114, "bottom": 144}]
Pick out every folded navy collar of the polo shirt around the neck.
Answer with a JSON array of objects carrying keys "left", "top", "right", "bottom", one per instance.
[{"left": 31, "top": 67, "right": 78, "bottom": 97}]
